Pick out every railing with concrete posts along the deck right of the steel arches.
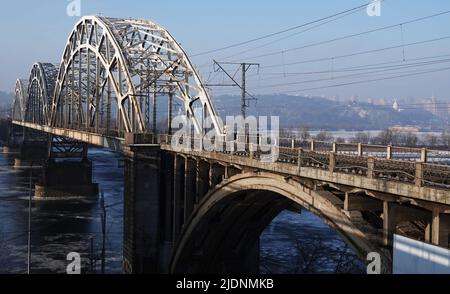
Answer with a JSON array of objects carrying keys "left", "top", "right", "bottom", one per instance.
[{"left": 160, "top": 135, "right": 450, "bottom": 188}]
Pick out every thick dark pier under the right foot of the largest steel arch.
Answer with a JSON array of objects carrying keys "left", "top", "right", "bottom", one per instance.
[{"left": 123, "top": 146, "right": 162, "bottom": 273}]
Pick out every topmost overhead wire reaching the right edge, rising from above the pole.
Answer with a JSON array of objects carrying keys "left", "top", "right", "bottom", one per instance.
[{"left": 229, "top": 10, "right": 450, "bottom": 61}]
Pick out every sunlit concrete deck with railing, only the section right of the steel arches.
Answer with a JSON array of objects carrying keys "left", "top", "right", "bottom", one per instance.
[{"left": 161, "top": 136, "right": 450, "bottom": 205}]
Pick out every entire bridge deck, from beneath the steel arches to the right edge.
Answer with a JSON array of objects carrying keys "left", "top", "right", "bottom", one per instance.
[{"left": 13, "top": 121, "right": 450, "bottom": 205}]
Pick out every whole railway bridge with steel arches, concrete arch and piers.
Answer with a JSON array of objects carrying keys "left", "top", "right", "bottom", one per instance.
[{"left": 6, "top": 16, "right": 450, "bottom": 273}]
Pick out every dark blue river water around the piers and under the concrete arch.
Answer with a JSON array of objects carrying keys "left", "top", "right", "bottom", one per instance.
[{"left": 0, "top": 148, "right": 365, "bottom": 273}]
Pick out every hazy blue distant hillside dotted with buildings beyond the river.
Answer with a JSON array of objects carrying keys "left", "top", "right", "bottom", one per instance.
[{"left": 214, "top": 94, "right": 446, "bottom": 130}]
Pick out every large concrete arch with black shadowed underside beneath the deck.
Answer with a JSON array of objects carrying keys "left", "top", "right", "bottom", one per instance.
[{"left": 169, "top": 172, "right": 390, "bottom": 273}]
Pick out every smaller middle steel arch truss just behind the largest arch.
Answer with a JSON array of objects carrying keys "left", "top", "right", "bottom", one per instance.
[{"left": 24, "top": 62, "right": 58, "bottom": 125}]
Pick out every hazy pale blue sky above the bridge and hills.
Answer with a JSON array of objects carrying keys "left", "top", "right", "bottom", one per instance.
[{"left": 0, "top": 0, "right": 450, "bottom": 99}]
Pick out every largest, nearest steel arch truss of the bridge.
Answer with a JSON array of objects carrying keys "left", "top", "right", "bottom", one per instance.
[{"left": 51, "top": 16, "right": 222, "bottom": 136}]
